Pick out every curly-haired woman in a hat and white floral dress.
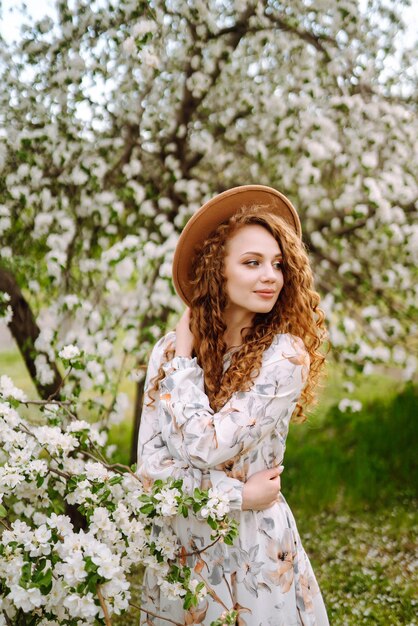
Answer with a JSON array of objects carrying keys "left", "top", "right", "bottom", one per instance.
[{"left": 138, "top": 185, "right": 328, "bottom": 626}]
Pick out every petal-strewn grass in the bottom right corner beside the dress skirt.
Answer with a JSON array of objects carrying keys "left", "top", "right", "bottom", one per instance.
[{"left": 299, "top": 501, "right": 418, "bottom": 626}]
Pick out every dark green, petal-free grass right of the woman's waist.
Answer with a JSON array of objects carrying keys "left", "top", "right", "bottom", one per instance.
[{"left": 282, "top": 385, "right": 418, "bottom": 514}]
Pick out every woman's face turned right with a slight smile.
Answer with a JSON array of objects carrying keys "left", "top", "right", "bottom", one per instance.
[{"left": 225, "top": 224, "right": 283, "bottom": 313}]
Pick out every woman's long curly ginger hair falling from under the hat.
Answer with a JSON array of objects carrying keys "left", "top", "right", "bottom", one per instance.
[{"left": 150, "top": 205, "right": 327, "bottom": 421}]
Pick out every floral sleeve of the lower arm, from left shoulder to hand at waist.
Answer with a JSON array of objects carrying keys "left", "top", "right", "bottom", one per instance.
[{"left": 136, "top": 334, "right": 244, "bottom": 509}]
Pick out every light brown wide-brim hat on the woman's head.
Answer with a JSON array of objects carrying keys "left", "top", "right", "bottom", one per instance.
[{"left": 173, "top": 185, "right": 302, "bottom": 305}]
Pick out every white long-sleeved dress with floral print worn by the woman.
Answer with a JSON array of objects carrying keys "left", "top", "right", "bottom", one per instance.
[{"left": 137, "top": 333, "right": 329, "bottom": 626}]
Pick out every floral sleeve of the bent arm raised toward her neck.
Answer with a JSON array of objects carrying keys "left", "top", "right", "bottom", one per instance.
[{"left": 160, "top": 333, "right": 309, "bottom": 470}]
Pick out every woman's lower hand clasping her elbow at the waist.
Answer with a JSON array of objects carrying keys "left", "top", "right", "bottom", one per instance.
[{"left": 241, "top": 465, "right": 284, "bottom": 511}]
